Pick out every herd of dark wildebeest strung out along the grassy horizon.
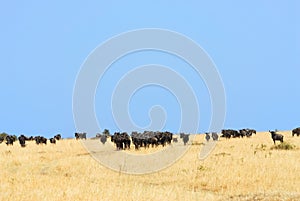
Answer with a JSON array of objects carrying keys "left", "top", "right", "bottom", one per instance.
[{"left": 0, "top": 127, "right": 300, "bottom": 150}]
